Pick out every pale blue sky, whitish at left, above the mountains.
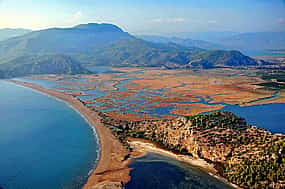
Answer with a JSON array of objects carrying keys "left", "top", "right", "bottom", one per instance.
[{"left": 0, "top": 0, "right": 285, "bottom": 34}]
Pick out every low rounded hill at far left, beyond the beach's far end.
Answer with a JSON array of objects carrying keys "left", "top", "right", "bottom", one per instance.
[{"left": 0, "top": 55, "right": 91, "bottom": 78}]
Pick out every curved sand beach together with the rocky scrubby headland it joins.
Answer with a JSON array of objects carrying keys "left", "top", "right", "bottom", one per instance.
[{"left": 10, "top": 80, "right": 285, "bottom": 189}]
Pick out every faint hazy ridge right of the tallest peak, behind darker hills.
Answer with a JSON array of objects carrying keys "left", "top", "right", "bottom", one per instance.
[{"left": 138, "top": 35, "right": 224, "bottom": 49}]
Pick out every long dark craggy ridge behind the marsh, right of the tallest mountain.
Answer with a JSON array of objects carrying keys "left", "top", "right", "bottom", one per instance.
[{"left": 79, "top": 38, "right": 262, "bottom": 69}]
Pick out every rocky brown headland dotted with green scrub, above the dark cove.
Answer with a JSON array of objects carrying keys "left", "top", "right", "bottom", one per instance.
[{"left": 103, "top": 111, "right": 285, "bottom": 188}]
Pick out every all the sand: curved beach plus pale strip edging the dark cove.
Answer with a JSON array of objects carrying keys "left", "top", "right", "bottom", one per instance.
[{"left": 7, "top": 80, "right": 240, "bottom": 189}]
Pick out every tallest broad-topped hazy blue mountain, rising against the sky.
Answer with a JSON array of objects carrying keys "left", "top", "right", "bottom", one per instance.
[{"left": 0, "top": 24, "right": 130, "bottom": 59}]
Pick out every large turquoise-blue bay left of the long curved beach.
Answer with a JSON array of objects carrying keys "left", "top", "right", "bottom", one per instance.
[{"left": 0, "top": 81, "right": 98, "bottom": 189}]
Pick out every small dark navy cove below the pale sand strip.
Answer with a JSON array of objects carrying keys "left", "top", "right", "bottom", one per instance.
[{"left": 126, "top": 153, "right": 231, "bottom": 189}]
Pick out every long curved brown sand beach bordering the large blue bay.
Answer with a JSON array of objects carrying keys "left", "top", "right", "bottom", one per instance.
[{"left": 7, "top": 80, "right": 131, "bottom": 189}]
